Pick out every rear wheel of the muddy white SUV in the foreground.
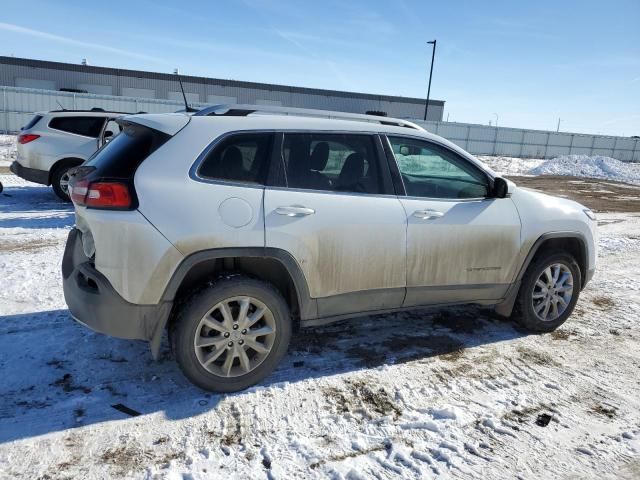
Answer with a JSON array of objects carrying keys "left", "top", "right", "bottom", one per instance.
[{"left": 173, "top": 276, "right": 291, "bottom": 392}]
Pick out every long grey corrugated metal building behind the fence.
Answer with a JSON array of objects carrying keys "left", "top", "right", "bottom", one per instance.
[{"left": 0, "top": 56, "right": 444, "bottom": 121}]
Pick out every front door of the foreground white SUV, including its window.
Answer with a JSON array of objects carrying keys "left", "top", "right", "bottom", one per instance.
[{"left": 388, "top": 136, "right": 520, "bottom": 306}]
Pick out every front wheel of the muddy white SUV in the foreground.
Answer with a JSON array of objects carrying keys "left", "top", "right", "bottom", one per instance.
[{"left": 514, "top": 252, "right": 582, "bottom": 332}]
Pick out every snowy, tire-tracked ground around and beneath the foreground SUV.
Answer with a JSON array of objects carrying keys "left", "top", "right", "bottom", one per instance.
[{"left": 0, "top": 175, "right": 640, "bottom": 479}]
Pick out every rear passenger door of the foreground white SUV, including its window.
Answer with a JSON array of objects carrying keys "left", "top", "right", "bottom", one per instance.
[{"left": 264, "top": 132, "right": 406, "bottom": 317}]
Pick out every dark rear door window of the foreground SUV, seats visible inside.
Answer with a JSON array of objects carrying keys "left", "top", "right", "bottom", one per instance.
[{"left": 282, "top": 133, "right": 382, "bottom": 194}]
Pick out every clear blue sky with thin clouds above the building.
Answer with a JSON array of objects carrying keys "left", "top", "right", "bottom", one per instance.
[{"left": 0, "top": 0, "right": 640, "bottom": 135}]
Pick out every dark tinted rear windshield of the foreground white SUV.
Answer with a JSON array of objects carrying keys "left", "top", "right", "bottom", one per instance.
[{"left": 84, "top": 123, "right": 171, "bottom": 178}]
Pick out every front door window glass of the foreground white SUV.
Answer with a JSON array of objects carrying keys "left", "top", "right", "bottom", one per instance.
[{"left": 389, "top": 137, "right": 489, "bottom": 199}]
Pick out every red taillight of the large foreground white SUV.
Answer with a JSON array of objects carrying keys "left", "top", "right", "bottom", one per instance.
[{"left": 69, "top": 180, "right": 133, "bottom": 210}]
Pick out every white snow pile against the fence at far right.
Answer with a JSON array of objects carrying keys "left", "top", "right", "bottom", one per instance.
[{"left": 528, "top": 155, "right": 640, "bottom": 184}]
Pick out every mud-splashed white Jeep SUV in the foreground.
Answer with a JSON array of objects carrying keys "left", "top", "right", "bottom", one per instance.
[{"left": 62, "top": 106, "right": 596, "bottom": 391}]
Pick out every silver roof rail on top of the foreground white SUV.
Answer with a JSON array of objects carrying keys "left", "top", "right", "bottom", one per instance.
[{"left": 194, "top": 104, "right": 424, "bottom": 130}]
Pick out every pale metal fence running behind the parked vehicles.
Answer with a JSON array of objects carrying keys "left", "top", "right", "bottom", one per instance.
[{"left": 0, "top": 87, "right": 640, "bottom": 162}]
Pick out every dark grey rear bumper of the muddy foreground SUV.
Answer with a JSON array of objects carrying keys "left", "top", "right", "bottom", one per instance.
[{"left": 62, "top": 228, "right": 172, "bottom": 344}]
